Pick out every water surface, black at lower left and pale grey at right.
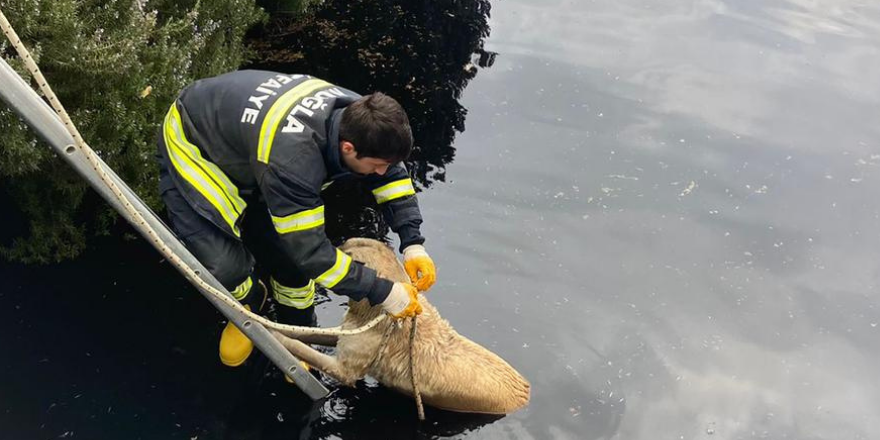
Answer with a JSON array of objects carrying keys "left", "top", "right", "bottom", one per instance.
[{"left": 0, "top": 0, "right": 880, "bottom": 440}]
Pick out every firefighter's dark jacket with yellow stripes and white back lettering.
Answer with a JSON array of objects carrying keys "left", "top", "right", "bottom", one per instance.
[{"left": 163, "top": 70, "right": 424, "bottom": 304}]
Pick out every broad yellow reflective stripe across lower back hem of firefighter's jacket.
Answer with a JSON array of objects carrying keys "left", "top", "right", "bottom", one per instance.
[{"left": 164, "top": 105, "right": 247, "bottom": 236}]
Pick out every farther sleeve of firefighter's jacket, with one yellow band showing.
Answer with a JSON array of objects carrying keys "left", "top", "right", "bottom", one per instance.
[{"left": 368, "top": 163, "right": 425, "bottom": 252}]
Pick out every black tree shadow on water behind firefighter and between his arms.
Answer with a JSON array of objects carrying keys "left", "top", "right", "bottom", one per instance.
[{"left": 248, "top": 0, "right": 496, "bottom": 243}]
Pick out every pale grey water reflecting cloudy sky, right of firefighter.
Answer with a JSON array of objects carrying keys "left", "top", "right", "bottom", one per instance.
[{"left": 424, "top": 0, "right": 880, "bottom": 439}]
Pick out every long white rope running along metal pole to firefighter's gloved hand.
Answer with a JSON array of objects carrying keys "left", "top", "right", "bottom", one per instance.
[{"left": 0, "top": 6, "right": 385, "bottom": 337}]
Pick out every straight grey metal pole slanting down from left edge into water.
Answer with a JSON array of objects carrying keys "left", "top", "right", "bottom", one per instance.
[{"left": 0, "top": 58, "right": 329, "bottom": 400}]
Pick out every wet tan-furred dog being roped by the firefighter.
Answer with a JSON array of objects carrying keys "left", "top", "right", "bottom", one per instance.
[{"left": 274, "top": 238, "right": 530, "bottom": 414}]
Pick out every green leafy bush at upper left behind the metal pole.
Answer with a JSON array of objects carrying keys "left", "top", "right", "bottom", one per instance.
[{"left": 0, "top": 0, "right": 263, "bottom": 263}]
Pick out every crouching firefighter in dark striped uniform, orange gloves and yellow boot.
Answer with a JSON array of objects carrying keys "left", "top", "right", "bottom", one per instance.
[{"left": 158, "top": 70, "right": 436, "bottom": 367}]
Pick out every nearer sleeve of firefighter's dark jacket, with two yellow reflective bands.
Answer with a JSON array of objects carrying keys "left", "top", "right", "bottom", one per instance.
[{"left": 260, "top": 160, "right": 393, "bottom": 305}]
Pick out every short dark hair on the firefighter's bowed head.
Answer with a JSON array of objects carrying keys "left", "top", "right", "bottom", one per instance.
[{"left": 339, "top": 92, "right": 413, "bottom": 163}]
